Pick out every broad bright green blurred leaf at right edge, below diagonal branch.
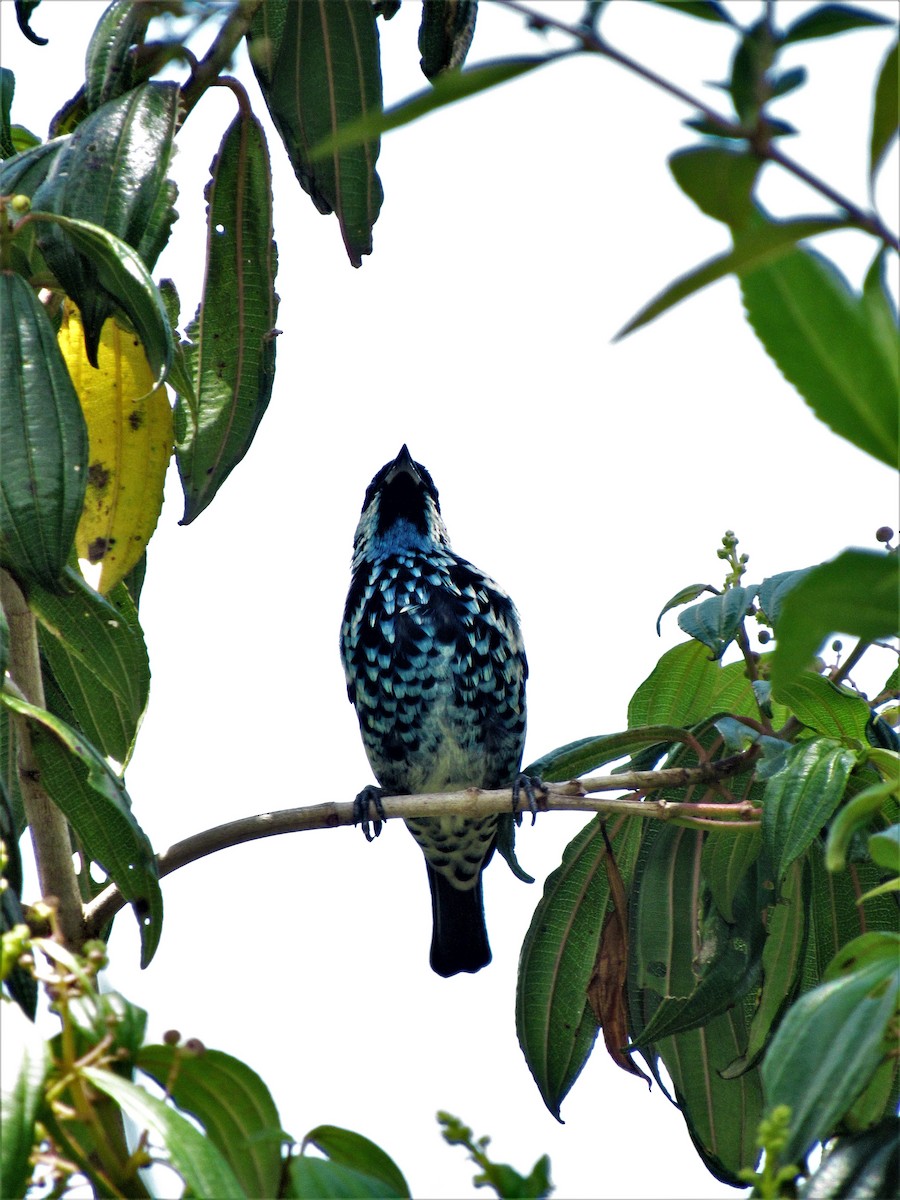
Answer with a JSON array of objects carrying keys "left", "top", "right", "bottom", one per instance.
[{"left": 740, "top": 250, "right": 900, "bottom": 468}]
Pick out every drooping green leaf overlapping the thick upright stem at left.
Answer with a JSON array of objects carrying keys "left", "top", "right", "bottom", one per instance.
[{"left": 2, "top": 694, "right": 162, "bottom": 966}]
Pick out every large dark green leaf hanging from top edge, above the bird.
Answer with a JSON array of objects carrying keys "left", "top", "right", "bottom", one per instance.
[{"left": 250, "top": 0, "right": 383, "bottom": 266}]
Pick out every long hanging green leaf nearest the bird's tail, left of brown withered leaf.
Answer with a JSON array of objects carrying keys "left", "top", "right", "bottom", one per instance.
[{"left": 516, "top": 817, "right": 641, "bottom": 1120}]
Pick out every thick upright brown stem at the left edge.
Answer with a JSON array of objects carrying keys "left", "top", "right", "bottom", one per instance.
[{"left": 0, "top": 570, "right": 84, "bottom": 950}]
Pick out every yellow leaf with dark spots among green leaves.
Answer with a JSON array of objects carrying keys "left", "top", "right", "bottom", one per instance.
[{"left": 59, "top": 301, "right": 172, "bottom": 594}]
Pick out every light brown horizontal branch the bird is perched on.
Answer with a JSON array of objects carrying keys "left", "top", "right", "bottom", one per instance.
[{"left": 84, "top": 746, "right": 760, "bottom": 937}]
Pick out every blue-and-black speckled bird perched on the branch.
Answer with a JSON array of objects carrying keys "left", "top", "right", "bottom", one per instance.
[{"left": 341, "top": 445, "right": 532, "bottom": 977}]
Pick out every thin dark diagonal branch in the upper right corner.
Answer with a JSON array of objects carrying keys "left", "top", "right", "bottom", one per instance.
[{"left": 498, "top": 0, "right": 900, "bottom": 251}]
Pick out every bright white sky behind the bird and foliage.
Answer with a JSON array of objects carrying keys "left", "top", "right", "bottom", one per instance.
[{"left": 0, "top": 0, "right": 898, "bottom": 1198}]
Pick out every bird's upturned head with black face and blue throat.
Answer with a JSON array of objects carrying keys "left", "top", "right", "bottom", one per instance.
[{"left": 353, "top": 446, "right": 450, "bottom": 568}]
